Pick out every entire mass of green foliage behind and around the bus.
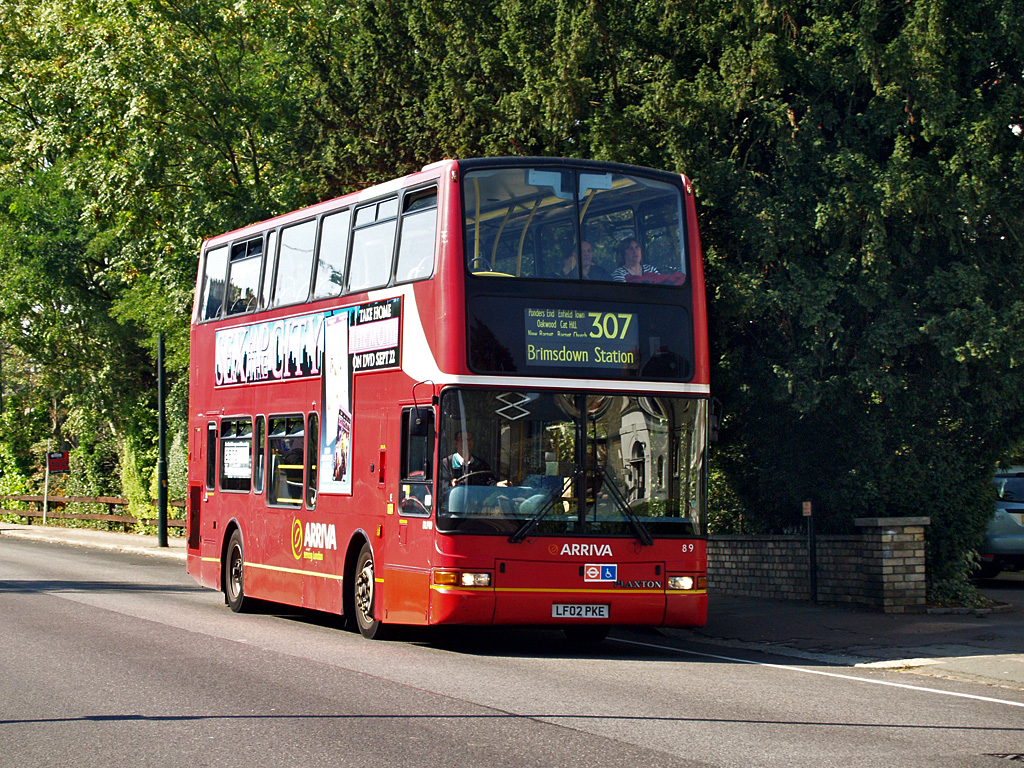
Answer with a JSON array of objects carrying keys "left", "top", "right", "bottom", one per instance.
[{"left": 0, "top": 0, "right": 1024, "bottom": 584}]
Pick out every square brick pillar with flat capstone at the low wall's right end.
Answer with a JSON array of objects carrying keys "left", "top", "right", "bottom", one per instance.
[{"left": 854, "top": 517, "right": 932, "bottom": 613}]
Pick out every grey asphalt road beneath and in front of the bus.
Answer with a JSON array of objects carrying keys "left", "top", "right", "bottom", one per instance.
[{"left": 0, "top": 538, "right": 1024, "bottom": 768}]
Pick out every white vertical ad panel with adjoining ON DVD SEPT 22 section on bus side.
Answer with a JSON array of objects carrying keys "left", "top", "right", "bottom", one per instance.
[{"left": 319, "top": 297, "right": 401, "bottom": 494}]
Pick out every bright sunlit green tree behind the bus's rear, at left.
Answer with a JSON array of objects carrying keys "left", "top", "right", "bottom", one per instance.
[{"left": 0, "top": 0, "right": 323, "bottom": 512}]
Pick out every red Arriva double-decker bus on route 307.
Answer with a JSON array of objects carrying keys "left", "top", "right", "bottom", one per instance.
[{"left": 187, "top": 158, "right": 710, "bottom": 640}]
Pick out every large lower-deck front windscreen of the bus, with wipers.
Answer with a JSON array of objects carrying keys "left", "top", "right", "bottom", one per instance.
[{"left": 437, "top": 390, "right": 707, "bottom": 540}]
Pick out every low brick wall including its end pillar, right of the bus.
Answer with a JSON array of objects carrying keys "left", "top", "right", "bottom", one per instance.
[{"left": 708, "top": 517, "right": 931, "bottom": 613}]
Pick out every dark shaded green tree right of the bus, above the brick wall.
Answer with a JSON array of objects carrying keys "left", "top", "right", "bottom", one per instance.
[{"left": 638, "top": 0, "right": 1024, "bottom": 584}]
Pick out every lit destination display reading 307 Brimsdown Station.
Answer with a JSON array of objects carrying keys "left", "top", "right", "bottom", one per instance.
[{"left": 524, "top": 306, "right": 640, "bottom": 369}]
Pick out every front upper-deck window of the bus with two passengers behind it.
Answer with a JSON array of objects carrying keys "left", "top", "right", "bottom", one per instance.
[{"left": 463, "top": 168, "right": 686, "bottom": 285}]
